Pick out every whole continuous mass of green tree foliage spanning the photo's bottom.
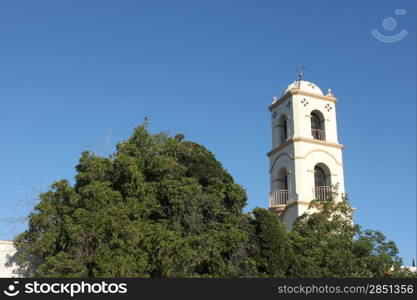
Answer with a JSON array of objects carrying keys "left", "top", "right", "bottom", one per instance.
[{"left": 15, "top": 123, "right": 408, "bottom": 278}]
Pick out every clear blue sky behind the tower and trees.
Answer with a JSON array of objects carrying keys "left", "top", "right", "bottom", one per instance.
[{"left": 0, "top": 0, "right": 416, "bottom": 265}]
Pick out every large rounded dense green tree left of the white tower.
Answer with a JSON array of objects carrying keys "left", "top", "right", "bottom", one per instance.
[{"left": 15, "top": 124, "right": 254, "bottom": 277}]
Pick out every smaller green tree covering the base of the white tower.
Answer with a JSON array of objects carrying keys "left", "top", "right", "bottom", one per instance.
[{"left": 288, "top": 193, "right": 401, "bottom": 278}]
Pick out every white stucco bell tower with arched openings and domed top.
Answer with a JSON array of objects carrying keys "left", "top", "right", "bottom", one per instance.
[{"left": 268, "top": 73, "right": 345, "bottom": 228}]
